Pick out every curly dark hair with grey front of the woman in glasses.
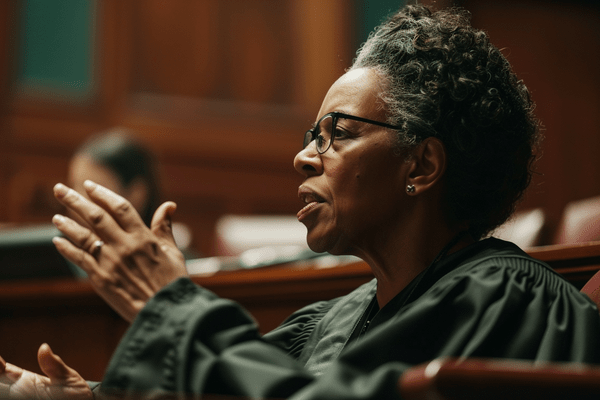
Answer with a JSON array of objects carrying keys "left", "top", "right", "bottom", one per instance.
[{"left": 350, "top": 5, "right": 541, "bottom": 239}]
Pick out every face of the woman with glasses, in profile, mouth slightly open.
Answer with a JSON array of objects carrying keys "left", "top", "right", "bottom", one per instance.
[{"left": 294, "top": 69, "right": 408, "bottom": 256}]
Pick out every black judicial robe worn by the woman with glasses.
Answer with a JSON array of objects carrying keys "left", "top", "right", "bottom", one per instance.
[{"left": 100, "top": 238, "right": 600, "bottom": 399}]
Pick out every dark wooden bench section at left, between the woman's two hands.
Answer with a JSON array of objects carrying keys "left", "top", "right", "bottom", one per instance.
[{"left": 0, "top": 280, "right": 128, "bottom": 380}]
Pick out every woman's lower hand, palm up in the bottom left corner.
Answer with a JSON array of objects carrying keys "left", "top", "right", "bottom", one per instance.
[{"left": 0, "top": 344, "right": 94, "bottom": 400}]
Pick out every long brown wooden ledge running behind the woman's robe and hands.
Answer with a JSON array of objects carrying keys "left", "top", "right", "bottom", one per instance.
[{"left": 0, "top": 242, "right": 600, "bottom": 380}]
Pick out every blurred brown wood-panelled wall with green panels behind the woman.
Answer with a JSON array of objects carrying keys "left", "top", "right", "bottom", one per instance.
[{"left": 0, "top": 0, "right": 600, "bottom": 256}]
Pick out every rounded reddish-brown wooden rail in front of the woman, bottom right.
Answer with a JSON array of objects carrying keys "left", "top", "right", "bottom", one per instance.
[{"left": 398, "top": 359, "right": 600, "bottom": 400}]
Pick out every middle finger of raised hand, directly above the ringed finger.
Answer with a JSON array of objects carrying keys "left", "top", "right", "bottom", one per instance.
[{"left": 54, "top": 183, "right": 123, "bottom": 242}]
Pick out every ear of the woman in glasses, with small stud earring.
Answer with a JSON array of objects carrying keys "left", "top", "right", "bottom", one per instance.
[{"left": 406, "top": 137, "right": 446, "bottom": 195}]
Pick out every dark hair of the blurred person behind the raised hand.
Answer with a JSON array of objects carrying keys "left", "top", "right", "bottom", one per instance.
[{"left": 75, "top": 128, "right": 161, "bottom": 226}]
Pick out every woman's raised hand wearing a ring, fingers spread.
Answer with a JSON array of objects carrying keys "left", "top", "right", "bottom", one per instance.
[{"left": 52, "top": 181, "right": 187, "bottom": 321}]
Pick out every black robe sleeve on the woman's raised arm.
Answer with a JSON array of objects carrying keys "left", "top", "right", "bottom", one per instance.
[{"left": 102, "top": 278, "right": 313, "bottom": 398}]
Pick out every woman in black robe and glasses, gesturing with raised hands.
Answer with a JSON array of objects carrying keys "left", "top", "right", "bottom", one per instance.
[{"left": 5, "top": 6, "right": 600, "bottom": 399}]
